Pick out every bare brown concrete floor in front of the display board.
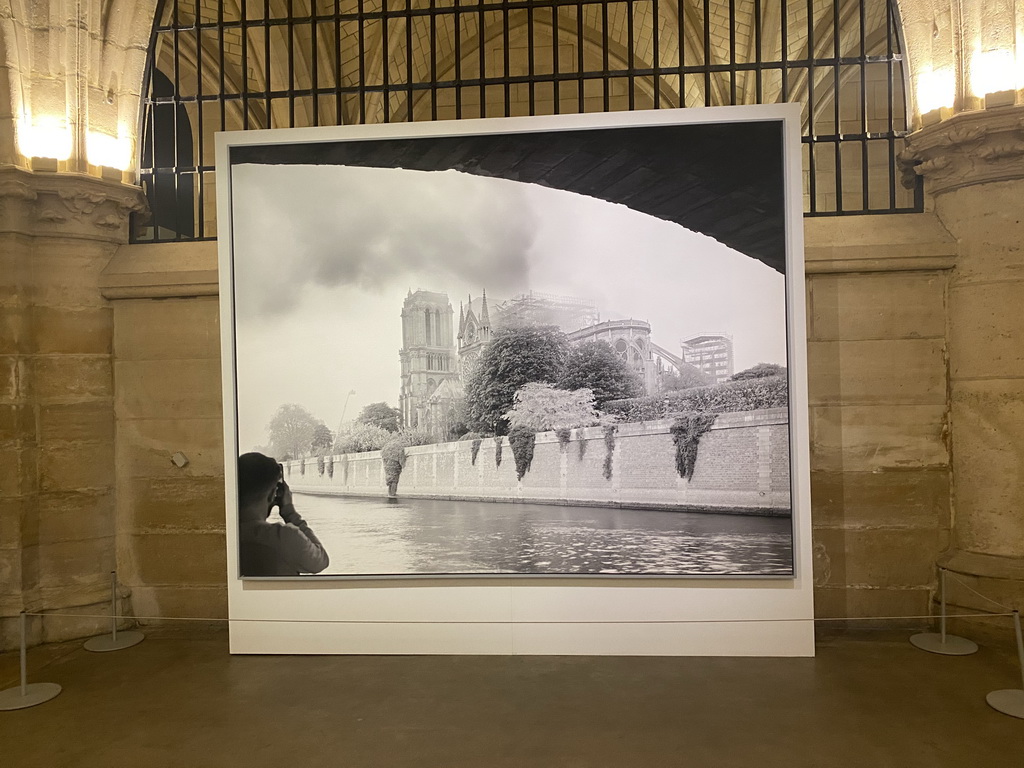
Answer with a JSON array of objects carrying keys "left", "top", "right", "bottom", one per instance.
[{"left": 0, "top": 628, "right": 1024, "bottom": 768}]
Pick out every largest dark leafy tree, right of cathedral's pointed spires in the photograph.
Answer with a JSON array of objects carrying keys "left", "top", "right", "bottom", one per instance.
[{"left": 466, "top": 326, "right": 569, "bottom": 434}]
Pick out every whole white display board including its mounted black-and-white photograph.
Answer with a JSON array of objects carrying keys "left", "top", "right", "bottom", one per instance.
[{"left": 217, "top": 104, "right": 813, "bottom": 655}]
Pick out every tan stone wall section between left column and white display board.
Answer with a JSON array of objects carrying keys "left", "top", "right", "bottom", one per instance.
[{"left": 102, "top": 243, "right": 227, "bottom": 617}]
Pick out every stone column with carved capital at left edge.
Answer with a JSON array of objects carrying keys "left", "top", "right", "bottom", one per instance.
[{"left": 0, "top": 166, "right": 141, "bottom": 648}]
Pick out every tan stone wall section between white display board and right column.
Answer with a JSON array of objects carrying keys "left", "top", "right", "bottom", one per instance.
[{"left": 805, "top": 214, "right": 955, "bottom": 616}]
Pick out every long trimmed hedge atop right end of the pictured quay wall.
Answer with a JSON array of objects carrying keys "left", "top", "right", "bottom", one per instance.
[{"left": 604, "top": 376, "right": 790, "bottom": 422}]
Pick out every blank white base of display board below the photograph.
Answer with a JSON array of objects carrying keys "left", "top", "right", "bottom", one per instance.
[{"left": 230, "top": 580, "right": 814, "bottom": 656}]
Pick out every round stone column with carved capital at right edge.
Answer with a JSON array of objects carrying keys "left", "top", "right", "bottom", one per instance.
[{"left": 904, "top": 106, "right": 1024, "bottom": 626}]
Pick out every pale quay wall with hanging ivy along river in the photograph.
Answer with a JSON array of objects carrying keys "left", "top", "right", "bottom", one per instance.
[{"left": 285, "top": 409, "right": 791, "bottom": 515}]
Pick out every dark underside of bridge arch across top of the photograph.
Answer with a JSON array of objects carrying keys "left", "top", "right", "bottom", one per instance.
[{"left": 230, "top": 120, "right": 785, "bottom": 273}]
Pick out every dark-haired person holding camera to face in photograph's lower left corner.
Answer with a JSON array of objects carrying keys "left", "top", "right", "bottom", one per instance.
[{"left": 239, "top": 453, "right": 330, "bottom": 577}]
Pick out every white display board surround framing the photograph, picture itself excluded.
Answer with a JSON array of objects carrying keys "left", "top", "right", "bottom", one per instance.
[{"left": 217, "top": 104, "right": 813, "bottom": 655}]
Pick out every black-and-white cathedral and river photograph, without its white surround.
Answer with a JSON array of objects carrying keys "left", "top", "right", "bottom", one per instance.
[{"left": 225, "top": 120, "right": 794, "bottom": 578}]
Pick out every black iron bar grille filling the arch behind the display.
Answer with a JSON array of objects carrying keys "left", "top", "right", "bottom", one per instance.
[{"left": 132, "top": 0, "right": 923, "bottom": 242}]
